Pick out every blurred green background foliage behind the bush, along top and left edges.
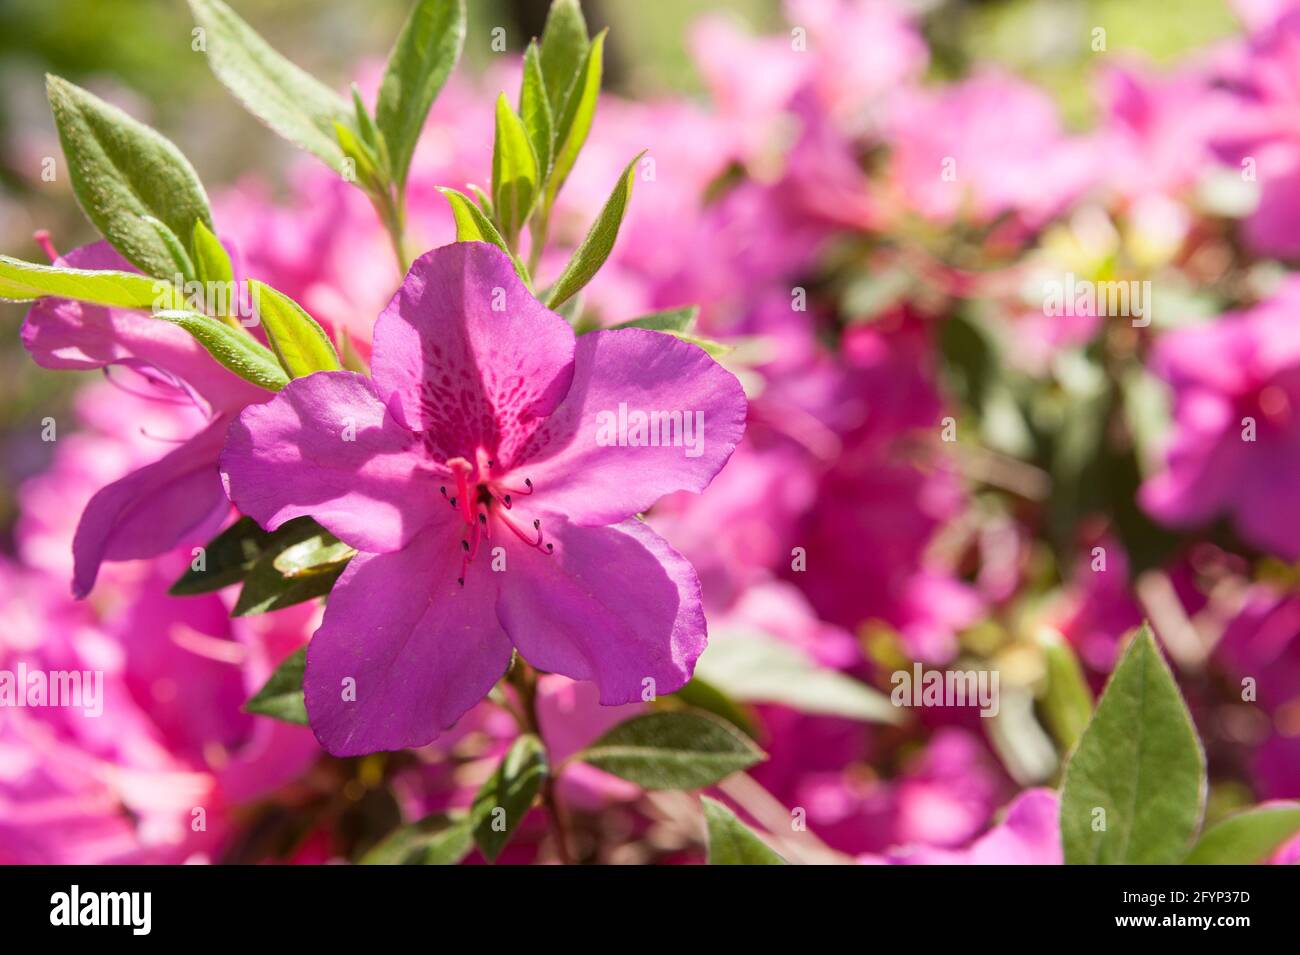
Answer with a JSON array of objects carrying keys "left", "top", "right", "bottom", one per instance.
[{"left": 0, "top": 0, "right": 1236, "bottom": 551}]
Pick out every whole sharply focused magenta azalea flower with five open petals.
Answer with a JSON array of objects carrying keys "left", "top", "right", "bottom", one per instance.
[{"left": 222, "top": 243, "right": 746, "bottom": 755}]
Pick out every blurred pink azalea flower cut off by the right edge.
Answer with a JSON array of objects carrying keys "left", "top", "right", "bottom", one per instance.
[{"left": 1140, "top": 281, "right": 1300, "bottom": 559}]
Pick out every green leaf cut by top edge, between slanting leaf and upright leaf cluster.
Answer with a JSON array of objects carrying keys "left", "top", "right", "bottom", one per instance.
[{"left": 374, "top": 0, "right": 465, "bottom": 188}]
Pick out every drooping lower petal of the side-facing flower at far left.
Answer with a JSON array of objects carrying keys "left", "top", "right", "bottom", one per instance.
[{"left": 73, "top": 416, "right": 230, "bottom": 598}]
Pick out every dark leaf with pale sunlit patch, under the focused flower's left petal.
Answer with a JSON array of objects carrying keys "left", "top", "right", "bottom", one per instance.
[{"left": 230, "top": 517, "right": 354, "bottom": 617}]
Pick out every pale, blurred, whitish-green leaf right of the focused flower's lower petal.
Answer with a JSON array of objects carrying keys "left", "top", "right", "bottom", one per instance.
[{"left": 696, "top": 631, "right": 902, "bottom": 724}]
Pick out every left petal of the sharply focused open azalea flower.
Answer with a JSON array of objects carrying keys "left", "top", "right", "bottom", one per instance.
[{"left": 221, "top": 372, "right": 456, "bottom": 554}]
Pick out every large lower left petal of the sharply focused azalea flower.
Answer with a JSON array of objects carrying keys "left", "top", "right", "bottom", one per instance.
[{"left": 303, "top": 534, "right": 511, "bottom": 756}]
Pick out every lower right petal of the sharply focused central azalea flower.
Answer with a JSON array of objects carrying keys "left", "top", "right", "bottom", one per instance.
[{"left": 496, "top": 518, "right": 706, "bottom": 706}]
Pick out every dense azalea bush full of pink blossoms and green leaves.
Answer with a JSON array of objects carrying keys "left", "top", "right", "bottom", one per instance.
[{"left": 0, "top": 0, "right": 1300, "bottom": 864}]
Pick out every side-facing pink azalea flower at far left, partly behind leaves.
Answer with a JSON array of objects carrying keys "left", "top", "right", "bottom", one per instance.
[{"left": 22, "top": 242, "right": 268, "bottom": 598}]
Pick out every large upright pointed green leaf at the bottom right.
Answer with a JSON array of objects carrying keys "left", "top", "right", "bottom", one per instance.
[{"left": 1061, "top": 625, "right": 1205, "bottom": 865}]
